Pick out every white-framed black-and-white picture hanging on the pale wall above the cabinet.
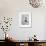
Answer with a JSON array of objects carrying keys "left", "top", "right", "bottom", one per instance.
[{"left": 19, "top": 12, "right": 31, "bottom": 27}]
